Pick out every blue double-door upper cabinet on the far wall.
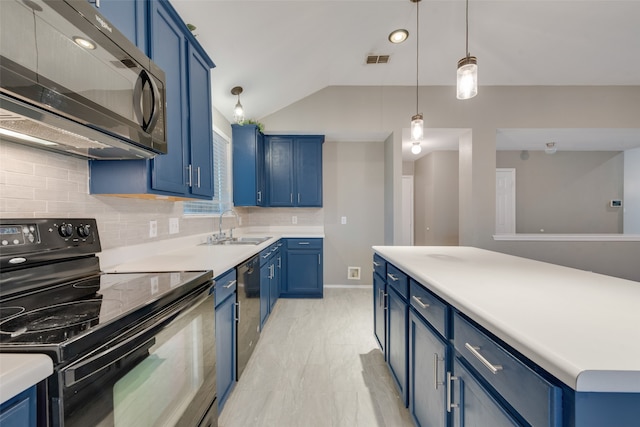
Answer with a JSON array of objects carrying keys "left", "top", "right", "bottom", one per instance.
[{"left": 265, "top": 135, "right": 324, "bottom": 207}]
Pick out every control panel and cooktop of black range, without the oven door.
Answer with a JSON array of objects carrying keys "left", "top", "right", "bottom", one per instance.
[{"left": 0, "top": 219, "right": 212, "bottom": 364}]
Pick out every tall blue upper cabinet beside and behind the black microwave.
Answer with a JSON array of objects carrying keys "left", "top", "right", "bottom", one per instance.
[{"left": 89, "top": 0, "right": 215, "bottom": 199}]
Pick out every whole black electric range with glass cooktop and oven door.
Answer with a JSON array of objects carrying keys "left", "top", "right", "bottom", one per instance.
[{"left": 0, "top": 219, "right": 217, "bottom": 427}]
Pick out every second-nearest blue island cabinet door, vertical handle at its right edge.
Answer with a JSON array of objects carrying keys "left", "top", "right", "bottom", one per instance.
[{"left": 408, "top": 310, "right": 449, "bottom": 427}]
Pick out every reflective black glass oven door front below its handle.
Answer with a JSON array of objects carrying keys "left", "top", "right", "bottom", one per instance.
[{"left": 63, "top": 298, "right": 216, "bottom": 427}]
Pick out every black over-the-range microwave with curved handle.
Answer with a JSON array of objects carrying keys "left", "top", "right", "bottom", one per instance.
[{"left": 0, "top": 0, "right": 167, "bottom": 159}]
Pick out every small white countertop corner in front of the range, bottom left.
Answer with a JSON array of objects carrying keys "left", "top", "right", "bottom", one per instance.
[{"left": 0, "top": 353, "right": 53, "bottom": 403}]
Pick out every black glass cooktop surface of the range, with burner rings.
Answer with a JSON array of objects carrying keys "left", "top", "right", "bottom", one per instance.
[{"left": 0, "top": 272, "right": 211, "bottom": 351}]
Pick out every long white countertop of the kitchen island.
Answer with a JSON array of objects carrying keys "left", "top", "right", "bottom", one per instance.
[{"left": 373, "top": 246, "right": 640, "bottom": 393}]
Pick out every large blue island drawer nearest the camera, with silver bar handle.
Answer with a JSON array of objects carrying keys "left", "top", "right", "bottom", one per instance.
[{"left": 453, "top": 312, "right": 562, "bottom": 426}]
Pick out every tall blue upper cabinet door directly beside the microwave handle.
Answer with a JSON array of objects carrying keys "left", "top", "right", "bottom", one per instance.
[{"left": 151, "top": 1, "right": 189, "bottom": 194}]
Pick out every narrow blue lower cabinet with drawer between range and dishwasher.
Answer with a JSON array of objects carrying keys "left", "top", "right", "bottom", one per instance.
[{"left": 215, "top": 269, "right": 238, "bottom": 412}]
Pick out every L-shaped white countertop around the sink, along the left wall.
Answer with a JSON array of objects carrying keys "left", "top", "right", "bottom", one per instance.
[{"left": 98, "top": 227, "right": 324, "bottom": 277}]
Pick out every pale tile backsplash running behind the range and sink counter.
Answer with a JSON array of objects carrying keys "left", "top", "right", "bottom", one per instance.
[{"left": 0, "top": 141, "right": 323, "bottom": 249}]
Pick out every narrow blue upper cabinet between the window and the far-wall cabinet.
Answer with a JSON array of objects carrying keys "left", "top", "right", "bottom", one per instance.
[{"left": 231, "top": 124, "right": 267, "bottom": 206}]
